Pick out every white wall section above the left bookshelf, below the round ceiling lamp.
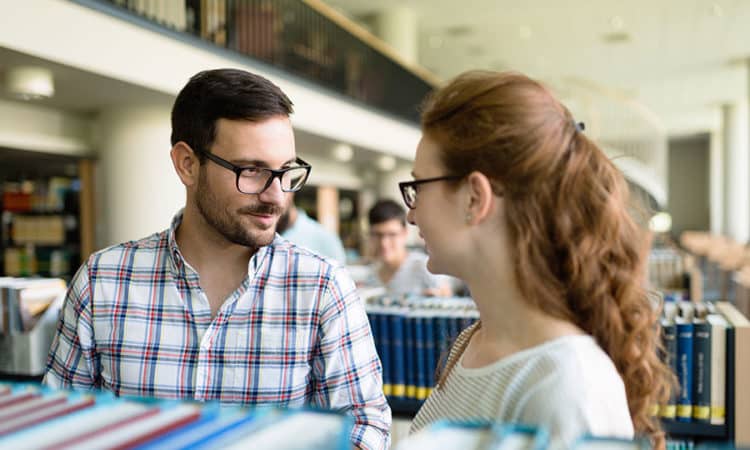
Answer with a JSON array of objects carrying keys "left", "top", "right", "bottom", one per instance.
[{"left": 0, "top": 100, "right": 94, "bottom": 156}]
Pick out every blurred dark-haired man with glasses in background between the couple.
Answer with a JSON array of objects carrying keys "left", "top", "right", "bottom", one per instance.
[{"left": 368, "top": 200, "right": 452, "bottom": 296}]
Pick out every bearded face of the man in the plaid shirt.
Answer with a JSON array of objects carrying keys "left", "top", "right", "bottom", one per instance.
[{"left": 195, "top": 116, "right": 296, "bottom": 248}]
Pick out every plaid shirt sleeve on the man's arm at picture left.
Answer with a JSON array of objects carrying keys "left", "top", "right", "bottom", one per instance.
[{"left": 43, "top": 263, "right": 98, "bottom": 390}]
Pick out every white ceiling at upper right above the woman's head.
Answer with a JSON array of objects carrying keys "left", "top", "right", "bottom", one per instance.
[{"left": 327, "top": 0, "right": 750, "bottom": 134}]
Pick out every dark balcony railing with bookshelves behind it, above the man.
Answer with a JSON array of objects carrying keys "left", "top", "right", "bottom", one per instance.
[{"left": 75, "top": 0, "right": 434, "bottom": 122}]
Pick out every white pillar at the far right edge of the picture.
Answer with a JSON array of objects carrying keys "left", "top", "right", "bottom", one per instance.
[{"left": 722, "top": 101, "right": 750, "bottom": 243}]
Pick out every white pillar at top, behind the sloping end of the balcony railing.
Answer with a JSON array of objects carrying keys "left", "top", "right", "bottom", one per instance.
[{"left": 373, "top": 5, "right": 419, "bottom": 64}]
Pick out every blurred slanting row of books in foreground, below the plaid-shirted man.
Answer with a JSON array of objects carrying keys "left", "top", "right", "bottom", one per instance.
[{"left": 0, "top": 383, "right": 353, "bottom": 450}]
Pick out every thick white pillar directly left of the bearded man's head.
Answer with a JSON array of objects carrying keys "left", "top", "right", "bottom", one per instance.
[{"left": 97, "top": 104, "right": 185, "bottom": 248}]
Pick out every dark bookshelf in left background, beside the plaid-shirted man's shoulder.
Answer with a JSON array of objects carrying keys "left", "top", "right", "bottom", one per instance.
[{"left": 0, "top": 149, "right": 94, "bottom": 279}]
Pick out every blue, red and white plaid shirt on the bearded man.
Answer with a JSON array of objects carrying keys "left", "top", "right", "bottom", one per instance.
[{"left": 45, "top": 213, "right": 391, "bottom": 449}]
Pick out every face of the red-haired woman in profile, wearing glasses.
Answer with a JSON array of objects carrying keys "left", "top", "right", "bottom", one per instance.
[{"left": 407, "top": 135, "right": 466, "bottom": 276}]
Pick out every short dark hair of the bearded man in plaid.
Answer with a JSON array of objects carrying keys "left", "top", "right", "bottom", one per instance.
[{"left": 171, "top": 69, "right": 293, "bottom": 162}]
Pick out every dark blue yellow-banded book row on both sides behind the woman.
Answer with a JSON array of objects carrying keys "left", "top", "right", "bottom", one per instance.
[{"left": 366, "top": 291, "right": 750, "bottom": 448}]
